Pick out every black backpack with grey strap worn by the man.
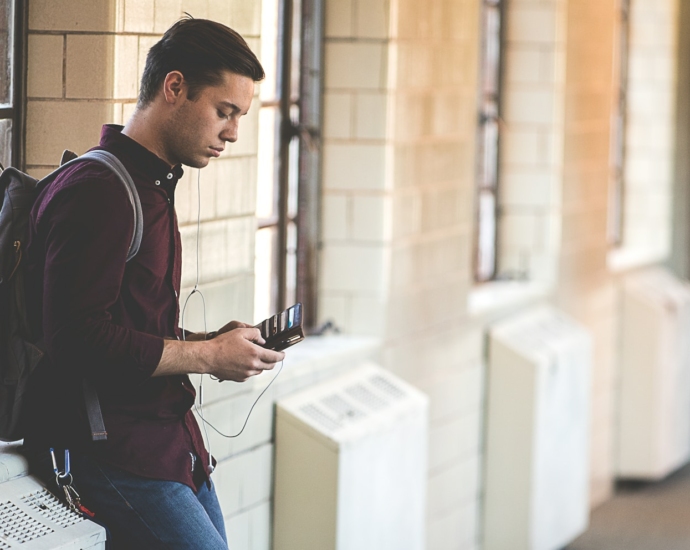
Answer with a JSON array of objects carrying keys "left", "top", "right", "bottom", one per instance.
[{"left": 0, "top": 150, "right": 143, "bottom": 441}]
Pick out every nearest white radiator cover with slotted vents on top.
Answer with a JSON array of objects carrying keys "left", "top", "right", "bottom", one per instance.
[{"left": 274, "top": 364, "right": 428, "bottom": 550}]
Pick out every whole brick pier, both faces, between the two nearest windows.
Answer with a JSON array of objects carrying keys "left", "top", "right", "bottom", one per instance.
[{"left": 320, "top": 0, "right": 483, "bottom": 549}]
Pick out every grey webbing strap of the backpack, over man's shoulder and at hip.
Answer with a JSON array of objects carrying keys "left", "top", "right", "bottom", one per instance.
[{"left": 51, "top": 149, "right": 144, "bottom": 441}]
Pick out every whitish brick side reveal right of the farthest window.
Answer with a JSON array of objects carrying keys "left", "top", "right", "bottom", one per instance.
[{"left": 610, "top": 0, "right": 678, "bottom": 267}]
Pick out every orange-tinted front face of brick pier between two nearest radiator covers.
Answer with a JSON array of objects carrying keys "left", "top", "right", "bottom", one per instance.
[{"left": 384, "top": 0, "right": 484, "bottom": 549}]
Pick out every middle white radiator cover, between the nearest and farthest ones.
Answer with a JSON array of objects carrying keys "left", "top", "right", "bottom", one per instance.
[{"left": 483, "top": 306, "right": 592, "bottom": 550}]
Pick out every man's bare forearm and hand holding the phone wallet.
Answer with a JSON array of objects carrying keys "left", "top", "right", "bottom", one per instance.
[{"left": 153, "top": 321, "right": 285, "bottom": 382}]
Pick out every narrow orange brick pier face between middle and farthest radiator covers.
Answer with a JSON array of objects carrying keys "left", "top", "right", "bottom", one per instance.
[{"left": 555, "top": 0, "right": 619, "bottom": 505}]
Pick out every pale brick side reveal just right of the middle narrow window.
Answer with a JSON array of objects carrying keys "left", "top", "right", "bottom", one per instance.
[{"left": 498, "top": 0, "right": 567, "bottom": 284}]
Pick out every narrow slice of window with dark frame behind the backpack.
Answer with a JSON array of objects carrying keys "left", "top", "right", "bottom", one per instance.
[{"left": 0, "top": 0, "right": 26, "bottom": 168}]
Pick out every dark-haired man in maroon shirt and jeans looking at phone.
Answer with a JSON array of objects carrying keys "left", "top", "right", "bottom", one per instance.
[{"left": 25, "top": 18, "right": 284, "bottom": 549}]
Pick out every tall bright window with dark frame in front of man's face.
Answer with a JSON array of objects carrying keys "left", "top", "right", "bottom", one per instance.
[{"left": 254, "top": 0, "right": 323, "bottom": 326}]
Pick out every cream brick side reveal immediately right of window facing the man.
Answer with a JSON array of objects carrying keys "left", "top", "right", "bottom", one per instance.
[{"left": 319, "top": 0, "right": 392, "bottom": 336}]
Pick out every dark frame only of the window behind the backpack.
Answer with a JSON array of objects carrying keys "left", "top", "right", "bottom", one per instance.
[{"left": 0, "top": 0, "right": 28, "bottom": 170}]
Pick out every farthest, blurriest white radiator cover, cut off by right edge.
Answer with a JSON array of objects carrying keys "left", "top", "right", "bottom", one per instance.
[{"left": 617, "top": 268, "right": 690, "bottom": 480}]
